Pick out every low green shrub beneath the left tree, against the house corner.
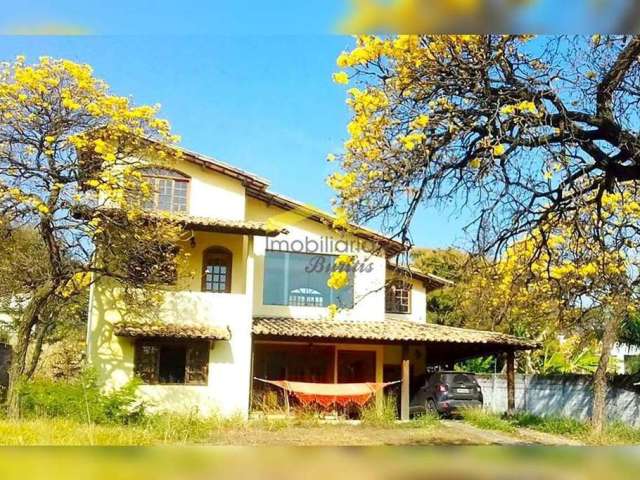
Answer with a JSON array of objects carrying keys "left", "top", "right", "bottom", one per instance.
[{"left": 18, "top": 370, "right": 144, "bottom": 424}]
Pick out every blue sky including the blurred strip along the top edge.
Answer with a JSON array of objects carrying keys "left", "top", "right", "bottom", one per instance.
[{"left": 0, "top": 0, "right": 630, "bottom": 251}]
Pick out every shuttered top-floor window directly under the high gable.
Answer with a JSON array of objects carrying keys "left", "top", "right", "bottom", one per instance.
[{"left": 144, "top": 168, "right": 189, "bottom": 212}]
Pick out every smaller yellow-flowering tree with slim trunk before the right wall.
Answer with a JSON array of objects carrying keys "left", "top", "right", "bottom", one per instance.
[{"left": 460, "top": 202, "right": 640, "bottom": 431}]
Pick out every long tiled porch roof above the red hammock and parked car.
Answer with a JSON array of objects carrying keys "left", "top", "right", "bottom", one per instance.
[{"left": 253, "top": 317, "right": 540, "bottom": 350}]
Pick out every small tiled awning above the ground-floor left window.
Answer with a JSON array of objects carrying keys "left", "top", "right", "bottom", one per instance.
[{"left": 113, "top": 322, "right": 231, "bottom": 340}]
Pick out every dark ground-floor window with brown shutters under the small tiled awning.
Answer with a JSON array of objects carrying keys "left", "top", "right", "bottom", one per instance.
[{"left": 134, "top": 340, "right": 209, "bottom": 385}]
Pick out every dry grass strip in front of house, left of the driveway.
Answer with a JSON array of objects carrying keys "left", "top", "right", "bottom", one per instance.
[{"left": 0, "top": 416, "right": 476, "bottom": 446}]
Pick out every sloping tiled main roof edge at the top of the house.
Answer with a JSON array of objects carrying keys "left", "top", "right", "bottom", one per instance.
[{"left": 175, "top": 147, "right": 408, "bottom": 256}]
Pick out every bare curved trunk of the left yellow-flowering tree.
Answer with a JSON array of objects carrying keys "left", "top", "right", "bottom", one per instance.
[{"left": 7, "top": 282, "right": 55, "bottom": 419}]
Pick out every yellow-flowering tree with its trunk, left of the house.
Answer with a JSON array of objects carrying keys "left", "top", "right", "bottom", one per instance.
[{"left": 0, "top": 57, "right": 184, "bottom": 416}]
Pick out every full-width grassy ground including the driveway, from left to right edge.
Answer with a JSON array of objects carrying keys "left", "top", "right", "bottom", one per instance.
[{"left": 0, "top": 410, "right": 640, "bottom": 446}]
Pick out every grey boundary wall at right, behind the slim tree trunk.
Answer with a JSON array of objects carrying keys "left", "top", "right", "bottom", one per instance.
[{"left": 476, "top": 374, "right": 640, "bottom": 427}]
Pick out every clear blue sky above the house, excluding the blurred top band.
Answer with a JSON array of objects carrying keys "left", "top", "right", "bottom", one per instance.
[{"left": 0, "top": 34, "right": 470, "bottom": 247}]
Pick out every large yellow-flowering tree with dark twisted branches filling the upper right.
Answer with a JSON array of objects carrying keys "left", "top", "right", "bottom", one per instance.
[{"left": 330, "top": 35, "right": 640, "bottom": 432}]
